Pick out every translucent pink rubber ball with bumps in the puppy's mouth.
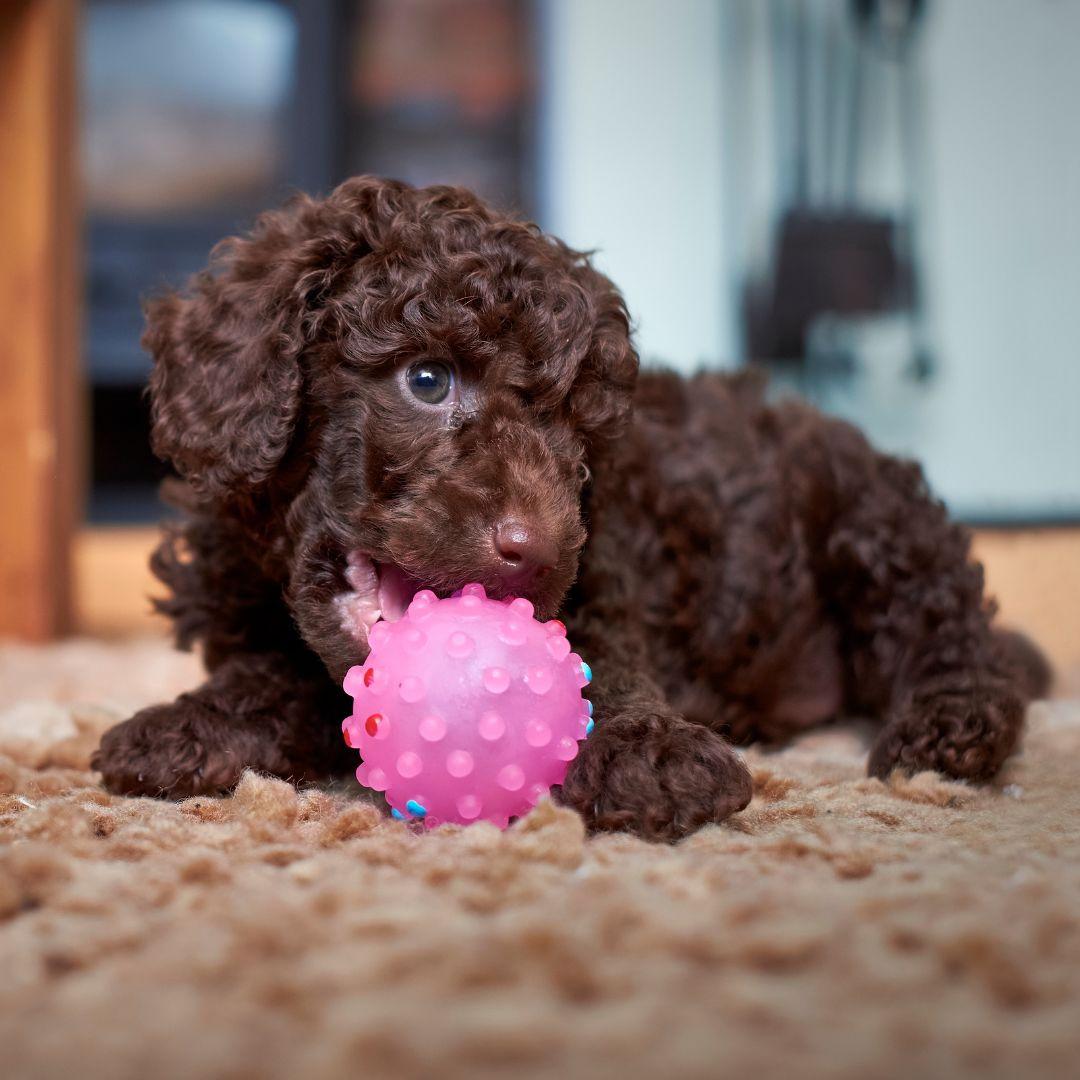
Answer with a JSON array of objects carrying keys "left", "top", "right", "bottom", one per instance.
[{"left": 341, "top": 584, "right": 593, "bottom": 828}]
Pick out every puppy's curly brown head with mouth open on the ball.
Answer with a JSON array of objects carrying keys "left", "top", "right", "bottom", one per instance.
[{"left": 145, "top": 177, "right": 637, "bottom": 674}]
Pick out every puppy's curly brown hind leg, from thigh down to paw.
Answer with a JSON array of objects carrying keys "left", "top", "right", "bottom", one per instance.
[{"left": 819, "top": 428, "right": 1029, "bottom": 781}]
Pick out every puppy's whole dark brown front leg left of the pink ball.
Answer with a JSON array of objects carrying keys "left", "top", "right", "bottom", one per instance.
[{"left": 92, "top": 653, "right": 353, "bottom": 798}]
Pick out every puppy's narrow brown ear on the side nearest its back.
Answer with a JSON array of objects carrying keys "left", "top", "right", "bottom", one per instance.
[{"left": 571, "top": 262, "right": 638, "bottom": 449}]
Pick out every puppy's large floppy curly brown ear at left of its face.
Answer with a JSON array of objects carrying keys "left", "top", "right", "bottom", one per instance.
[{"left": 143, "top": 177, "right": 409, "bottom": 497}]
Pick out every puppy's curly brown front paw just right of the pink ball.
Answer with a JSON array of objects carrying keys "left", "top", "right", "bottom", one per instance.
[{"left": 558, "top": 715, "right": 753, "bottom": 840}]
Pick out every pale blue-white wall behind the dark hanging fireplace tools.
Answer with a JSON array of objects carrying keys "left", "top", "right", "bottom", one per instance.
[{"left": 542, "top": 0, "right": 1080, "bottom": 517}]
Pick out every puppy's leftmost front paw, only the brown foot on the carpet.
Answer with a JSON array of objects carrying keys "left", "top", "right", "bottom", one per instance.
[{"left": 91, "top": 698, "right": 240, "bottom": 799}]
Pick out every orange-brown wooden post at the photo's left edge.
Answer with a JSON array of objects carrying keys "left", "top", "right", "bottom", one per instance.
[{"left": 0, "top": 0, "right": 79, "bottom": 640}]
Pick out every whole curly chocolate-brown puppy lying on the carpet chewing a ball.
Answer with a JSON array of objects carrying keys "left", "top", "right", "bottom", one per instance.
[{"left": 90, "top": 177, "right": 1044, "bottom": 839}]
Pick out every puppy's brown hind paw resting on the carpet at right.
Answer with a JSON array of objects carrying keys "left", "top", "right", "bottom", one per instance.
[{"left": 866, "top": 686, "right": 1024, "bottom": 782}]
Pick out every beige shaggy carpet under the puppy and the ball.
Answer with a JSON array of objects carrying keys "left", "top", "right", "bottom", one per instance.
[{"left": 0, "top": 642, "right": 1080, "bottom": 1080}]
